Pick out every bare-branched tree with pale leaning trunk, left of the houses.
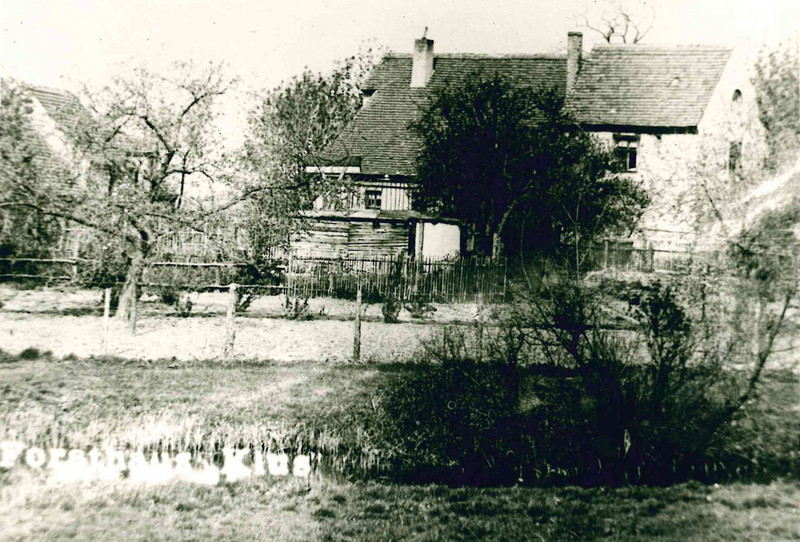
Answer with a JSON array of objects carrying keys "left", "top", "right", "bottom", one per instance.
[{"left": 0, "top": 63, "right": 239, "bottom": 329}]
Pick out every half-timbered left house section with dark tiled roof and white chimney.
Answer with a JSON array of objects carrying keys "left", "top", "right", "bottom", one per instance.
[{"left": 299, "top": 38, "right": 566, "bottom": 258}]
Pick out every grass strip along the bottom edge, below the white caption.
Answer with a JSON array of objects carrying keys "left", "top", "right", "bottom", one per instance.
[{"left": 0, "top": 479, "right": 800, "bottom": 542}]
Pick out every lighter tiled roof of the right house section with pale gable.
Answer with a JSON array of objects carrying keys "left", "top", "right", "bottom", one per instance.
[{"left": 567, "top": 45, "right": 731, "bottom": 129}]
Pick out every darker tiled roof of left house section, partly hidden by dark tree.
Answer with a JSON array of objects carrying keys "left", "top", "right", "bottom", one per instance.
[{"left": 328, "top": 54, "right": 567, "bottom": 176}]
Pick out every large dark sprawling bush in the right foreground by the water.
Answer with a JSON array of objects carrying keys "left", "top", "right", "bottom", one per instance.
[{"left": 376, "top": 272, "right": 796, "bottom": 486}]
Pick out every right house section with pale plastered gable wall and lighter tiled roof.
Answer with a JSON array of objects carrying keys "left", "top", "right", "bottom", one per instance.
[{"left": 566, "top": 33, "right": 767, "bottom": 250}]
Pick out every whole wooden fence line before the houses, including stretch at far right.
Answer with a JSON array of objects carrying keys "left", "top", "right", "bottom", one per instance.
[{"left": 0, "top": 241, "right": 715, "bottom": 303}]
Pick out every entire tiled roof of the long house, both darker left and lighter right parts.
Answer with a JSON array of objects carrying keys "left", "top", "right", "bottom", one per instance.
[{"left": 328, "top": 45, "right": 731, "bottom": 176}]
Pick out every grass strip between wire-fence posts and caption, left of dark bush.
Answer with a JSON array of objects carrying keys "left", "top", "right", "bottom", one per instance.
[{"left": 0, "top": 352, "right": 403, "bottom": 449}]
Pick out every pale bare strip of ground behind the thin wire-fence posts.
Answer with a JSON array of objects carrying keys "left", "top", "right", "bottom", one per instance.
[{"left": 0, "top": 286, "right": 462, "bottom": 363}]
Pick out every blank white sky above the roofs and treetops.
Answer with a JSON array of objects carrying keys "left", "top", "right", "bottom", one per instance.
[{"left": 0, "top": 0, "right": 800, "bottom": 142}]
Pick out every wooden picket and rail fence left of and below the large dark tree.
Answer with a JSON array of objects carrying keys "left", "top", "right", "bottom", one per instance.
[{"left": 0, "top": 251, "right": 506, "bottom": 303}]
